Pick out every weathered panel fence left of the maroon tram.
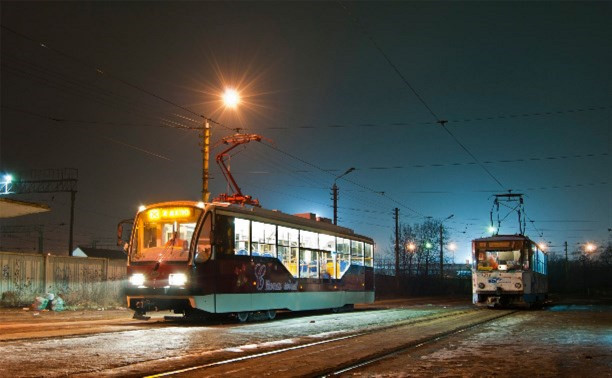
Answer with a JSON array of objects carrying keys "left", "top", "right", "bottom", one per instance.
[{"left": 0, "top": 252, "right": 127, "bottom": 306}]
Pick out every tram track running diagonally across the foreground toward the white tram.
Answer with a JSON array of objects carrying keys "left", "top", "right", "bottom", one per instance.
[{"left": 140, "top": 310, "right": 516, "bottom": 377}]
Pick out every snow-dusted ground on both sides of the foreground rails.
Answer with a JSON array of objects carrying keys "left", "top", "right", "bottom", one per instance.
[{"left": 0, "top": 298, "right": 612, "bottom": 377}]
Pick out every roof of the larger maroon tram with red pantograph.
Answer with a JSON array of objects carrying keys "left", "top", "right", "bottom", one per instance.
[{"left": 140, "top": 201, "right": 373, "bottom": 242}]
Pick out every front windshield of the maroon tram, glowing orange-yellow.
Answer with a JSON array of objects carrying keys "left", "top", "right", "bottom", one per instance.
[{"left": 130, "top": 206, "right": 202, "bottom": 262}]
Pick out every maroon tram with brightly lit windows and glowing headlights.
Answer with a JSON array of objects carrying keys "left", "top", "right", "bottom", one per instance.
[{"left": 122, "top": 201, "right": 374, "bottom": 321}]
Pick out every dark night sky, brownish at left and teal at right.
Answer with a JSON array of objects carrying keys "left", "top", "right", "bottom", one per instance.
[{"left": 0, "top": 2, "right": 612, "bottom": 261}]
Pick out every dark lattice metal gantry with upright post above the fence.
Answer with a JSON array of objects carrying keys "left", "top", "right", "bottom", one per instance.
[{"left": 2, "top": 168, "right": 79, "bottom": 255}]
